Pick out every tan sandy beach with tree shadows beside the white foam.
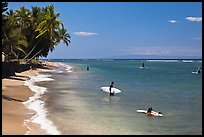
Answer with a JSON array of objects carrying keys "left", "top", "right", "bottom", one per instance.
[{"left": 2, "top": 62, "right": 57, "bottom": 135}]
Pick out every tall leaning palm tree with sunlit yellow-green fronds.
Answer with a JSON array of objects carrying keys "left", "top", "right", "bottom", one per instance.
[{"left": 25, "top": 5, "right": 61, "bottom": 59}]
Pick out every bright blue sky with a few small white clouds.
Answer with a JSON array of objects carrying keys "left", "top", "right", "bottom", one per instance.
[{"left": 8, "top": 2, "right": 202, "bottom": 59}]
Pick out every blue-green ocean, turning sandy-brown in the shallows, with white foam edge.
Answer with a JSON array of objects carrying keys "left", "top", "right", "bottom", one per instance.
[{"left": 23, "top": 59, "right": 202, "bottom": 135}]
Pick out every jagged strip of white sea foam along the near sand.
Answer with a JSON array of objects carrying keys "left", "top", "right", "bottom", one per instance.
[{"left": 23, "top": 75, "right": 60, "bottom": 135}]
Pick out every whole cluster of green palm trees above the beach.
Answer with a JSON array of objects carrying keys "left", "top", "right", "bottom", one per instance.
[{"left": 2, "top": 2, "right": 70, "bottom": 62}]
